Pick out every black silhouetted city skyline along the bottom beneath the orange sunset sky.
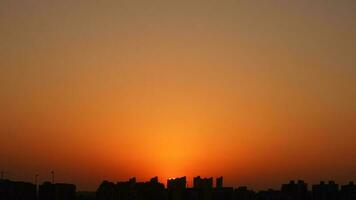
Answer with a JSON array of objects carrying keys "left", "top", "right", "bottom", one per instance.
[{"left": 0, "top": 177, "right": 356, "bottom": 200}]
